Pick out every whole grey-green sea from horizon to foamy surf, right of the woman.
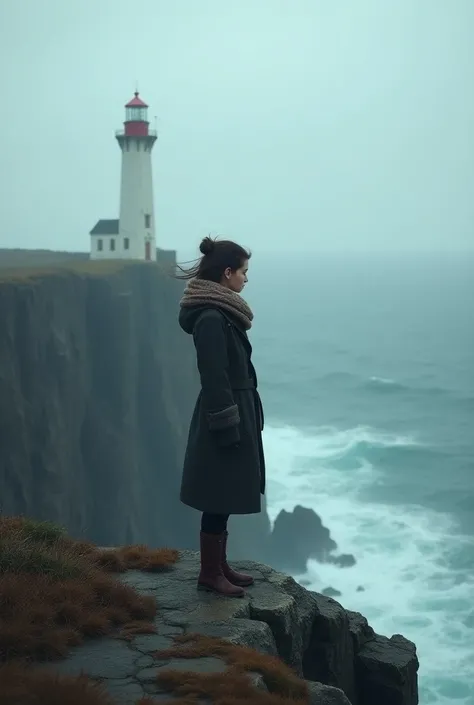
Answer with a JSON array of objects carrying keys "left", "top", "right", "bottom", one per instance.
[{"left": 243, "top": 252, "right": 474, "bottom": 705}]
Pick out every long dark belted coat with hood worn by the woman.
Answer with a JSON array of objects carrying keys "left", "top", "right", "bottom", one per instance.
[{"left": 179, "top": 306, "right": 265, "bottom": 514}]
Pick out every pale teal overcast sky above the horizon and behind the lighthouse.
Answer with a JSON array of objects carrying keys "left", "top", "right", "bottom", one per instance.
[{"left": 0, "top": 0, "right": 474, "bottom": 255}]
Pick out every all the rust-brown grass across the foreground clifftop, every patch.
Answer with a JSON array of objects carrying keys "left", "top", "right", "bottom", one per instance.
[{"left": 0, "top": 517, "right": 309, "bottom": 705}]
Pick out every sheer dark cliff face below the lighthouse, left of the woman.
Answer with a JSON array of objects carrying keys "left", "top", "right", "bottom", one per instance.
[{"left": 0, "top": 262, "right": 202, "bottom": 548}]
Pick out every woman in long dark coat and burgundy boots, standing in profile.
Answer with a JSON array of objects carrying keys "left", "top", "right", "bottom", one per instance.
[{"left": 179, "top": 237, "right": 265, "bottom": 597}]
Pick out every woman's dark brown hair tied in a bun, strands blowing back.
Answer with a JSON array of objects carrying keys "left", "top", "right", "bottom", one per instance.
[{"left": 176, "top": 235, "right": 252, "bottom": 282}]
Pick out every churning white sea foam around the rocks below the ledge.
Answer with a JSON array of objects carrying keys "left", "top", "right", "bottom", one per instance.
[{"left": 265, "top": 426, "right": 474, "bottom": 705}]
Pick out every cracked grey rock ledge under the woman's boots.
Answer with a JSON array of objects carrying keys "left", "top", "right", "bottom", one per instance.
[{"left": 35, "top": 551, "right": 418, "bottom": 705}]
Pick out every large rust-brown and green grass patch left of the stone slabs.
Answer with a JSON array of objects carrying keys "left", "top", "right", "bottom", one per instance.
[{"left": 0, "top": 517, "right": 178, "bottom": 662}]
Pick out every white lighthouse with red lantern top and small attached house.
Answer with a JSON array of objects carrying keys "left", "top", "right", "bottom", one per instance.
[{"left": 90, "top": 91, "right": 156, "bottom": 261}]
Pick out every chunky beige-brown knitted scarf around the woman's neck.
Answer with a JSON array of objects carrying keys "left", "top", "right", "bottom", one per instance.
[{"left": 180, "top": 278, "right": 253, "bottom": 330}]
